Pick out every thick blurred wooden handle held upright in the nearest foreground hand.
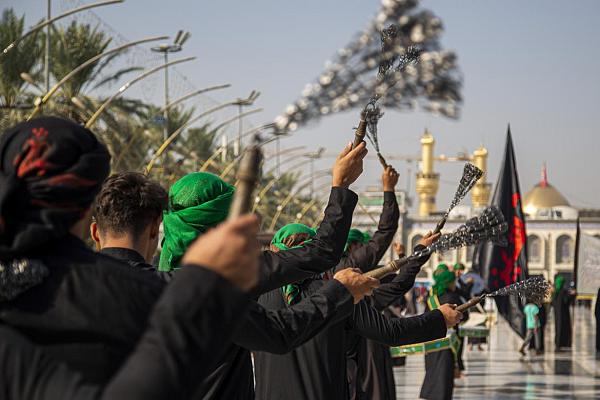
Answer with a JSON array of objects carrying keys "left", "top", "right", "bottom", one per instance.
[{"left": 229, "top": 145, "right": 262, "bottom": 219}]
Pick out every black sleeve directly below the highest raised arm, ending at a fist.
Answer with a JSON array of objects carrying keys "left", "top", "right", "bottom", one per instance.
[{"left": 233, "top": 280, "right": 354, "bottom": 354}]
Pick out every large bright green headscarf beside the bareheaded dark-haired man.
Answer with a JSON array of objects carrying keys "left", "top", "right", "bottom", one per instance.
[{"left": 158, "top": 172, "right": 235, "bottom": 271}]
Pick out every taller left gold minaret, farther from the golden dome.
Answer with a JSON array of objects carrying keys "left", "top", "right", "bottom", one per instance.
[{"left": 417, "top": 129, "right": 440, "bottom": 217}]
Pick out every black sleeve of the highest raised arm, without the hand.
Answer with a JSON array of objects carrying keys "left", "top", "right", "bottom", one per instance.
[{"left": 252, "top": 187, "right": 358, "bottom": 296}]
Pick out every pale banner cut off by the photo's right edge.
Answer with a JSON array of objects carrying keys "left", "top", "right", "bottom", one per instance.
[{"left": 577, "top": 232, "right": 600, "bottom": 295}]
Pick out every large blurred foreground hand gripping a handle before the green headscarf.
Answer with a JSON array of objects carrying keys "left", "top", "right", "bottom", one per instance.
[{"left": 182, "top": 214, "right": 260, "bottom": 291}]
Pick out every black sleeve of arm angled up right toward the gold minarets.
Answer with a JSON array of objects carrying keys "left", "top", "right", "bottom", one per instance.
[{"left": 371, "top": 244, "right": 429, "bottom": 311}]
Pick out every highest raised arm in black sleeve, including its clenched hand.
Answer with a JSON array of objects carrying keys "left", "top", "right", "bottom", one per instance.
[{"left": 253, "top": 143, "right": 367, "bottom": 296}]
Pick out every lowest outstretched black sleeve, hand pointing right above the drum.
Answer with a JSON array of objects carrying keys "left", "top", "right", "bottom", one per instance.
[{"left": 348, "top": 300, "right": 446, "bottom": 346}]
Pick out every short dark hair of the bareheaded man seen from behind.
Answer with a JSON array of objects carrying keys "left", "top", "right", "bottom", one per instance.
[{"left": 94, "top": 172, "right": 169, "bottom": 238}]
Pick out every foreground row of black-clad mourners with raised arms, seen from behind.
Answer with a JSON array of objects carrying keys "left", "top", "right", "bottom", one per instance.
[{"left": 0, "top": 117, "right": 463, "bottom": 400}]
